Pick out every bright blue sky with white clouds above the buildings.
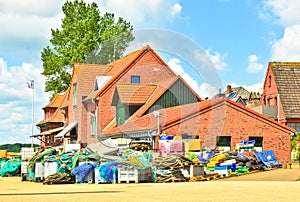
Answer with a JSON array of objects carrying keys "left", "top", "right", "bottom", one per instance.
[{"left": 0, "top": 0, "right": 300, "bottom": 144}]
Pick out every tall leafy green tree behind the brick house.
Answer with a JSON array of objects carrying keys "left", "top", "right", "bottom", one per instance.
[{"left": 41, "top": 0, "right": 134, "bottom": 97}]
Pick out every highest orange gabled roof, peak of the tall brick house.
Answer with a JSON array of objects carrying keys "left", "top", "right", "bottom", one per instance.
[{"left": 94, "top": 45, "right": 176, "bottom": 98}]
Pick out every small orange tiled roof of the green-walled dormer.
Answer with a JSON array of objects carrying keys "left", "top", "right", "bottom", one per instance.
[{"left": 113, "top": 84, "right": 157, "bottom": 106}]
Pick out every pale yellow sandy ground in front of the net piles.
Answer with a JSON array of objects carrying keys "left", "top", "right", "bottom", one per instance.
[{"left": 0, "top": 166, "right": 300, "bottom": 202}]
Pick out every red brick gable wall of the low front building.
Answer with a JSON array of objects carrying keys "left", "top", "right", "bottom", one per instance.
[{"left": 162, "top": 103, "right": 291, "bottom": 163}]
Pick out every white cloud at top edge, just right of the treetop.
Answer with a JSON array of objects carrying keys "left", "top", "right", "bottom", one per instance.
[{"left": 99, "top": 0, "right": 182, "bottom": 28}]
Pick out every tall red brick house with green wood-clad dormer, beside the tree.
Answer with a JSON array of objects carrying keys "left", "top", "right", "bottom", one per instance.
[{"left": 37, "top": 46, "right": 201, "bottom": 146}]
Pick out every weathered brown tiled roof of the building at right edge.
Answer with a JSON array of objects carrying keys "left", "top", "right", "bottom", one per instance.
[{"left": 269, "top": 62, "right": 300, "bottom": 118}]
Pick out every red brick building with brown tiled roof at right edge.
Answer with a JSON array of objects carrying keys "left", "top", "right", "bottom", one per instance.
[{"left": 260, "top": 62, "right": 300, "bottom": 131}]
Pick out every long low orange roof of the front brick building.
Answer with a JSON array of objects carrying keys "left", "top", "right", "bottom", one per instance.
[{"left": 105, "top": 98, "right": 295, "bottom": 135}]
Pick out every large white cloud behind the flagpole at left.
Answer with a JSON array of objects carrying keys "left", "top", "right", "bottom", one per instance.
[{"left": 0, "top": 58, "right": 49, "bottom": 144}]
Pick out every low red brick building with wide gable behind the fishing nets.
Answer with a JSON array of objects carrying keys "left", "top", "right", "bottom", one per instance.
[{"left": 106, "top": 98, "right": 295, "bottom": 163}]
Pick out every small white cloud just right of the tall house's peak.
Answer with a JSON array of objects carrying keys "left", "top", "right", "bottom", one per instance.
[{"left": 194, "top": 49, "right": 227, "bottom": 70}]
